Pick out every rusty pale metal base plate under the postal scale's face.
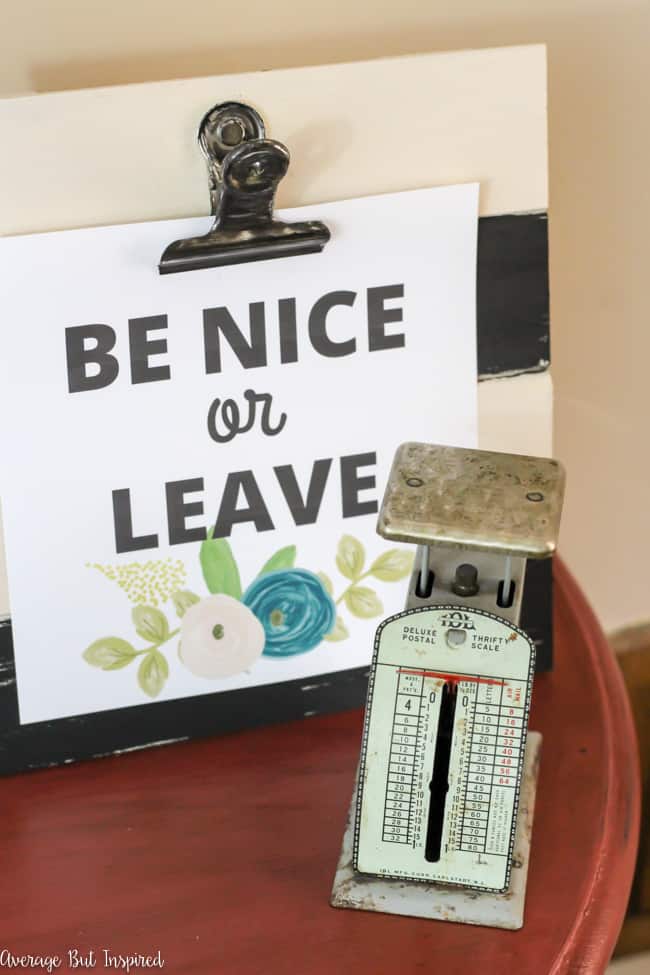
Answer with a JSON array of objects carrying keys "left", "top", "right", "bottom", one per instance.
[{"left": 330, "top": 731, "right": 542, "bottom": 931}]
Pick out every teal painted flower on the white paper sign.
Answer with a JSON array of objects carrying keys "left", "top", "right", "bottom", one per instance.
[{"left": 242, "top": 569, "right": 336, "bottom": 657}]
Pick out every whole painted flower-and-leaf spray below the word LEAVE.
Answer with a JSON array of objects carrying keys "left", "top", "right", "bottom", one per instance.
[{"left": 82, "top": 531, "right": 413, "bottom": 698}]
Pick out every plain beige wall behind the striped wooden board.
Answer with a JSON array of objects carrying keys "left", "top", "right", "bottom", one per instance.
[{"left": 0, "top": 0, "right": 650, "bottom": 628}]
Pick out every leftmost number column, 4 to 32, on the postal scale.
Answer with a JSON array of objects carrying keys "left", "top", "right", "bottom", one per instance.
[{"left": 382, "top": 673, "right": 424, "bottom": 843}]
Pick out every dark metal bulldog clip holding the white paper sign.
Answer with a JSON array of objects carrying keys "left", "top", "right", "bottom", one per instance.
[{"left": 158, "top": 102, "right": 330, "bottom": 274}]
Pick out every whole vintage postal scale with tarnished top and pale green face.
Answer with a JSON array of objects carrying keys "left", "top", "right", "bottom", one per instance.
[{"left": 332, "top": 443, "right": 564, "bottom": 928}]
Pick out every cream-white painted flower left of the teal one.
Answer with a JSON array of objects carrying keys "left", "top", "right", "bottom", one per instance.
[{"left": 178, "top": 593, "right": 266, "bottom": 678}]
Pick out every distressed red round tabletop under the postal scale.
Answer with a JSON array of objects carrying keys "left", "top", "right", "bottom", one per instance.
[{"left": 0, "top": 565, "right": 639, "bottom": 975}]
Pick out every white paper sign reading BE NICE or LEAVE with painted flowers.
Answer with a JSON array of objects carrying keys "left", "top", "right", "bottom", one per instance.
[{"left": 0, "top": 185, "right": 478, "bottom": 723}]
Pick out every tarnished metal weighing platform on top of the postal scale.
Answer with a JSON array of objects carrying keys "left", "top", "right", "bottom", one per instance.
[{"left": 377, "top": 443, "right": 564, "bottom": 558}]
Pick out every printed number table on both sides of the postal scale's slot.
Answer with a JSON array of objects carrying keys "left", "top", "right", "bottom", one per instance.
[{"left": 382, "top": 669, "right": 526, "bottom": 856}]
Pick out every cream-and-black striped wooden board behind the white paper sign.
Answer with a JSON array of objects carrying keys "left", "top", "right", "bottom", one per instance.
[{"left": 0, "top": 45, "right": 552, "bottom": 771}]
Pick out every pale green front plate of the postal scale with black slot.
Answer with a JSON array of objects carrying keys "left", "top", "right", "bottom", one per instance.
[{"left": 354, "top": 606, "right": 535, "bottom": 891}]
